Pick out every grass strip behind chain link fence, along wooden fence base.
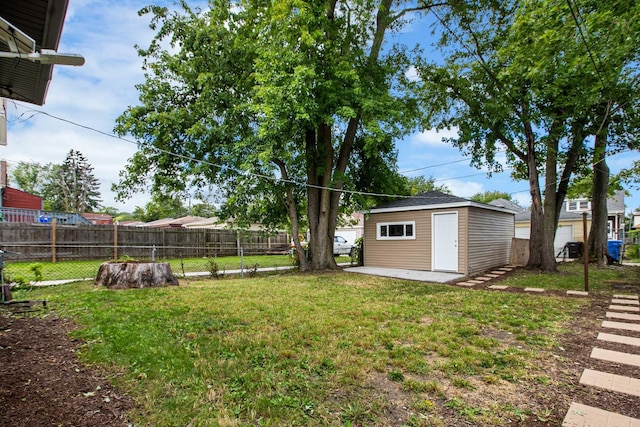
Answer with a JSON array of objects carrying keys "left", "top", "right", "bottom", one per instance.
[{"left": 5, "top": 255, "right": 304, "bottom": 282}]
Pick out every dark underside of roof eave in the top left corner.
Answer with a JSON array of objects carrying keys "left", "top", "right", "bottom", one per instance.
[{"left": 0, "top": 0, "right": 68, "bottom": 105}]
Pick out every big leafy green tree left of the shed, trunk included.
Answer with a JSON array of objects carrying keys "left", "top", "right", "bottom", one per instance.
[{"left": 115, "top": 0, "right": 440, "bottom": 270}]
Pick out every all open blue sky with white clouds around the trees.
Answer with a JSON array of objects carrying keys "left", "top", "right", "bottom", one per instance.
[{"left": 5, "top": 0, "right": 640, "bottom": 212}]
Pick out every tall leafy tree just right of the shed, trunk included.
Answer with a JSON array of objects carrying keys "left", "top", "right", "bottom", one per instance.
[{"left": 419, "top": 0, "right": 639, "bottom": 270}]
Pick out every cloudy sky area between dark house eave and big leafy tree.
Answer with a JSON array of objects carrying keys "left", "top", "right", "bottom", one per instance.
[{"left": 0, "top": 0, "right": 162, "bottom": 211}]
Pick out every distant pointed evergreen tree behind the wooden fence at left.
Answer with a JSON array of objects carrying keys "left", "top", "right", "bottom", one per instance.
[{"left": 43, "top": 150, "right": 101, "bottom": 213}]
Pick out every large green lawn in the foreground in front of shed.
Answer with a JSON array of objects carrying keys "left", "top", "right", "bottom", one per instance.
[{"left": 8, "top": 269, "right": 617, "bottom": 426}]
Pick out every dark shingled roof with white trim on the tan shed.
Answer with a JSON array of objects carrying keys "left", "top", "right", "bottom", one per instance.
[{"left": 370, "top": 191, "right": 514, "bottom": 213}]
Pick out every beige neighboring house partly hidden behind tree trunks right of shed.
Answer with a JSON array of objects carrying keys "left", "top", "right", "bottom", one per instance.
[{"left": 516, "top": 190, "right": 625, "bottom": 254}]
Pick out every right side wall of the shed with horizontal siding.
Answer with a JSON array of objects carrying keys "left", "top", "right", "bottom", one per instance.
[{"left": 467, "top": 208, "right": 515, "bottom": 274}]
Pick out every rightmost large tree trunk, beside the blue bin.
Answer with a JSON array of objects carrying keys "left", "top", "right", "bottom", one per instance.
[{"left": 589, "top": 131, "right": 609, "bottom": 266}]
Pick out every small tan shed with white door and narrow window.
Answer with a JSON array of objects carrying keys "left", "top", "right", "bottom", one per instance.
[{"left": 364, "top": 191, "right": 514, "bottom": 275}]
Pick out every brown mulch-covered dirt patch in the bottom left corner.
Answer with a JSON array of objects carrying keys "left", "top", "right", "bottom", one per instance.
[{"left": 0, "top": 309, "right": 132, "bottom": 427}]
